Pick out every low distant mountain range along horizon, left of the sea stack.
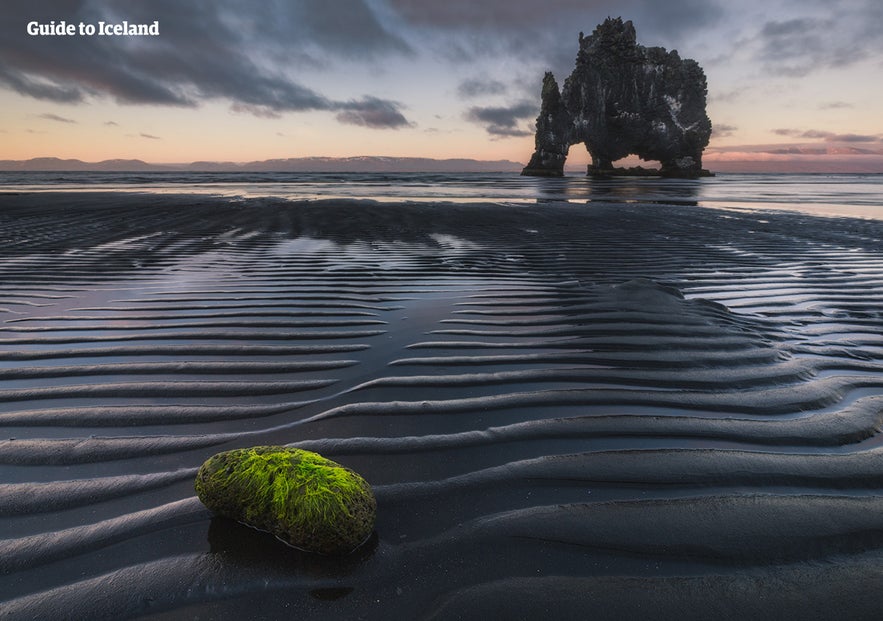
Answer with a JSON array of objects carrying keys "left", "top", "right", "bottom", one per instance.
[{"left": 0, "top": 156, "right": 523, "bottom": 173}]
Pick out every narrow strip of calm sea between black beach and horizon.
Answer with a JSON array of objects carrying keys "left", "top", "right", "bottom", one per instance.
[{"left": 0, "top": 172, "right": 883, "bottom": 219}]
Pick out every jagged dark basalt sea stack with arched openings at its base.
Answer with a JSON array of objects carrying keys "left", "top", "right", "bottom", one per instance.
[{"left": 521, "top": 18, "right": 711, "bottom": 177}]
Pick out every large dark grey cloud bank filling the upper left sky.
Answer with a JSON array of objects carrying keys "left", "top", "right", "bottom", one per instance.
[{"left": 0, "top": 0, "right": 410, "bottom": 127}]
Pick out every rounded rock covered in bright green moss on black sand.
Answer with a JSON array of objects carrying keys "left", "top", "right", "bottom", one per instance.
[{"left": 196, "top": 446, "right": 377, "bottom": 554}]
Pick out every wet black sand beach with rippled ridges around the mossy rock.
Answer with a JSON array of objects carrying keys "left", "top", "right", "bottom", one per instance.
[{"left": 0, "top": 192, "right": 883, "bottom": 620}]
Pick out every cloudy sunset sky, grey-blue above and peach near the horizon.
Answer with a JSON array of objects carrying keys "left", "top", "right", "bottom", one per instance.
[{"left": 0, "top": 0, "right": 883, "bottom": 172}]
